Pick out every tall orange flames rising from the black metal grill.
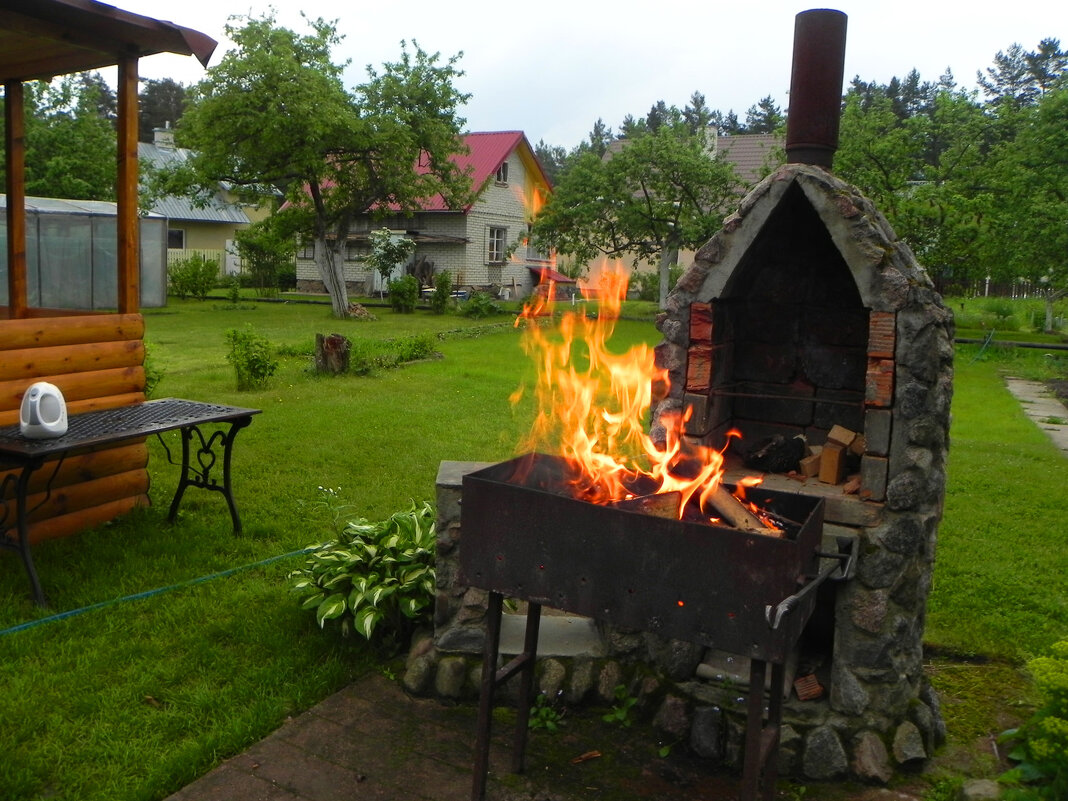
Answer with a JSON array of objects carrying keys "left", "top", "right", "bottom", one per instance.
[{"left": 512, "top": 264, "right": 766, "bottom": 522}]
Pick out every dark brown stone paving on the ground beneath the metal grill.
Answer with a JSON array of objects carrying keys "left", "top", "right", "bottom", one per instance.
[{"left": 167, "top": 674, "right": 920, "bottom": 801}]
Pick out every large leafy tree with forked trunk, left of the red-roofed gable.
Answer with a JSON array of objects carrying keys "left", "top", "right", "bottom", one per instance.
[{"left": 171, "top": 14, "right": 473, "bottom": 317}]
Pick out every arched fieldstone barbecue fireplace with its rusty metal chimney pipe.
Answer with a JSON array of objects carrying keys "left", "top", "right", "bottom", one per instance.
[{"left": 405, "top": 11, "right": 954, "bottom": 782}]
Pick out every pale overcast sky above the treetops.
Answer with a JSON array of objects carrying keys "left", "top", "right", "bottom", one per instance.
[{"left": 110, "top": 0, "right": 1068, "bottom": 150}]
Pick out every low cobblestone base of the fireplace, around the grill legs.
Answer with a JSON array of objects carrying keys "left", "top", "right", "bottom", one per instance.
[{"left": 416, "top": 461, "right": 945, "bottom": 782}]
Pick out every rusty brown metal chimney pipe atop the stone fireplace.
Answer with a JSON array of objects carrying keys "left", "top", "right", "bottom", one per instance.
[{"left": 786, "top": 9, "right": 846, "bottom": 170}]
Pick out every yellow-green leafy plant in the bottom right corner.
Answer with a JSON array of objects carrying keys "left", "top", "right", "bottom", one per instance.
[{"left": 1001, "top": 640, "right": 1068, "bottom": 801}]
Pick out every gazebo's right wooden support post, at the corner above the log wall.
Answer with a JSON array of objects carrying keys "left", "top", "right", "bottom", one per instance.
[{"left": 115, "top": 56, "right": 141, "bottom": 314}]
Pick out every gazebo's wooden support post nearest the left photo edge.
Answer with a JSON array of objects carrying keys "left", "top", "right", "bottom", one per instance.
[{"left": 3, "top": 81, "right": 27, "bottom": 318}]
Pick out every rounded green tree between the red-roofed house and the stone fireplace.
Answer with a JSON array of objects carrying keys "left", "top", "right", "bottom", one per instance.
[{"left": 533, "top": 114, "right": 737, "bottom": 304}]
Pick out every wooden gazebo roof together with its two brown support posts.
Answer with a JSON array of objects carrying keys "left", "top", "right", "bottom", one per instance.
[{"left": 0, "top": 0, "right": 216, "bottom": 318}]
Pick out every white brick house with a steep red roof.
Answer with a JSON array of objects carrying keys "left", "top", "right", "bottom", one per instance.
[{"left": 297, "top": 130, "right": 552, "bottom": 298}]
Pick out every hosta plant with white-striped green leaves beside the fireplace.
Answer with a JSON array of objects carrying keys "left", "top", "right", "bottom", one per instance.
[{"left": 289, "top": 502, "right": 435, "bottom": 643}]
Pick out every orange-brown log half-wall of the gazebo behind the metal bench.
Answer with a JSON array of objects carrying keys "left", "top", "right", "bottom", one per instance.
[{"left": 0, "top": 314, "right": 148, "bottom": 541}]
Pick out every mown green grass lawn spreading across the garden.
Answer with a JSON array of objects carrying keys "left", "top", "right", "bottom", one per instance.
[{"left": 0, "top": 300, "right": 1068, "bottom": 801}]
